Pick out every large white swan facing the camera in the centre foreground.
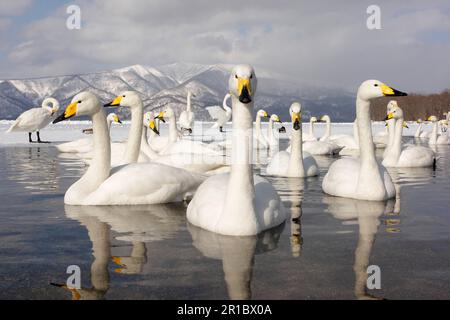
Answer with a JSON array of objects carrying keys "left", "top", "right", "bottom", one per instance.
[{"left": 187, "top": 65, "right": 286, "bottom": 236}]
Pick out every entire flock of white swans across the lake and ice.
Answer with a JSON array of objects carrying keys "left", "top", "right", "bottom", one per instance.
[{"left": 5, "top": 65, "right": 450, "bottom": 236}]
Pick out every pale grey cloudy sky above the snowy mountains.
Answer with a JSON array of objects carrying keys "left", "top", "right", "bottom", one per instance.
[{"left": 0, "top": 0, "right": 450, "bottom": 92}]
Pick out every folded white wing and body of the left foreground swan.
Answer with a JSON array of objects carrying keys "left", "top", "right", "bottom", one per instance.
[{"left": 86, "top": 163, "right": 205, "bottom": 205}]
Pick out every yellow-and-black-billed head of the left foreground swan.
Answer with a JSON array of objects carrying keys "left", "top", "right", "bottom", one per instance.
[{"left": 53, "top": 91, "right": 101, "bottom": 123}]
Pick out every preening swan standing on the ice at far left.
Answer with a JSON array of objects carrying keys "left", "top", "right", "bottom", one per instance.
[{"left": 6, "top": 98, "right": 59, "bottom": 143}]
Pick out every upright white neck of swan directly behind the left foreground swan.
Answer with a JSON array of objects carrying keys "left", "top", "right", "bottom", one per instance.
[{"left": 124, "top": 101, "right": 144, "bottom": 164}]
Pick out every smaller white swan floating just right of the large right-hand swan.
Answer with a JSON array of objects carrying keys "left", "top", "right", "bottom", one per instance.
[{"left": 382, "top": 104, "right": 436, "bottom": 168}]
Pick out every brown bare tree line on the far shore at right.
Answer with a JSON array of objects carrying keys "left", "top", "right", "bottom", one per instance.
[{"left": 371, "top": 89, "right": 450, "bottom": 121}]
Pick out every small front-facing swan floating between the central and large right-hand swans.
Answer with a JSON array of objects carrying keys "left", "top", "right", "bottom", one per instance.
[{"left": 266, "top": 102, "right": 319, "bottom": 178}]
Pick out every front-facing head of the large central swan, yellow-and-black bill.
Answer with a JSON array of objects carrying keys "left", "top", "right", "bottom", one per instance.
[{"left": 228, "top": 64, "right": 257, "bottom": 104}]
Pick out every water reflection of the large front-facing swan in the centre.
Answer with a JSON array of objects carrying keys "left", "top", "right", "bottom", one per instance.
[{"left": 187, "top": 223, "right": 284, "bottom": 300}]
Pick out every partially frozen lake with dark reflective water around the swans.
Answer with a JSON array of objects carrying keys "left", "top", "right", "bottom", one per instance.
[{"left": 0, "top": 121, "right": 450, "bottom": 299}]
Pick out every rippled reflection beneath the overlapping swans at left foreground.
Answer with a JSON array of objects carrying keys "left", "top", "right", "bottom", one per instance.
[{"left": 52, "top": 205, "right": 185, "bottom": 300}]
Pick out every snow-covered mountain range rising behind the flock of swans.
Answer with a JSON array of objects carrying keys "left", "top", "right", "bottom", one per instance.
[{"left": 0, "top": 63, "right": 355, "bottom": 121}]
